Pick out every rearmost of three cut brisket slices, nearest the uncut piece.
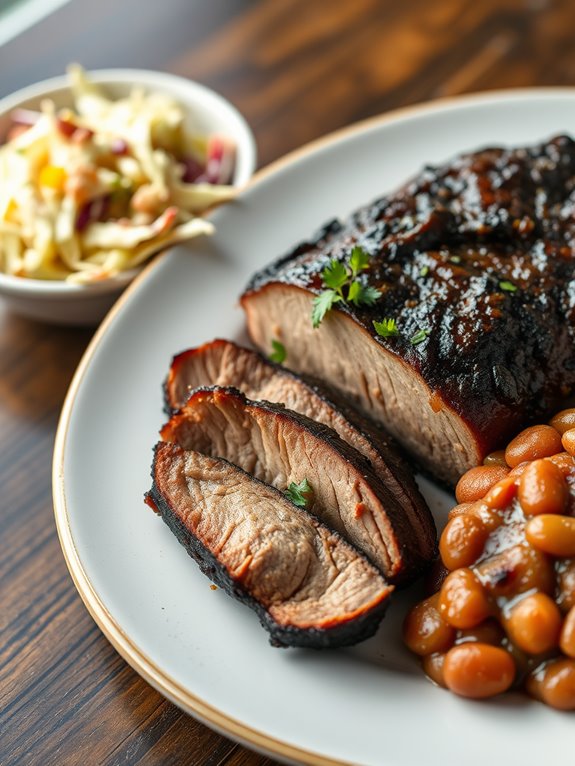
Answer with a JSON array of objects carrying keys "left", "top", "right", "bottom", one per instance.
[{"left": 165, "top": 340, "right": 436, "bottom": 560}]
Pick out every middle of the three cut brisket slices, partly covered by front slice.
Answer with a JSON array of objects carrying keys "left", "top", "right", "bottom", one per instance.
[{"left": 161, "top": 387, "right": 429, "bottom": 582}]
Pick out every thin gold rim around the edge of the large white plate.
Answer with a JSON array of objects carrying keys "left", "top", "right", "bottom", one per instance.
[{"left": 52, "top": 86, "right": 575, "bottom": 766}]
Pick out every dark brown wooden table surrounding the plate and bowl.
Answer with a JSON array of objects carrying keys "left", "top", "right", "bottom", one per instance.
[{"left": 0, "top": 0, "right": 575, "bottom": 766}]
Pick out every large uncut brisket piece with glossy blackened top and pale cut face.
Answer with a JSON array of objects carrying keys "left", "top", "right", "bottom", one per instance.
[{"left": 241, "top": 137, "right": 575, "bottom": 483}]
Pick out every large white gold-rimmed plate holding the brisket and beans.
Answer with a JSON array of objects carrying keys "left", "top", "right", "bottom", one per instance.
[{"left": 54, "top": 89, "right": 575, "bottom": 766}]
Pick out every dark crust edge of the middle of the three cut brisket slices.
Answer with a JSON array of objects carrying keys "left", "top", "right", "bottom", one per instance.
[{"left": 160, "top": 386, "right": 431, "bottom": 585}]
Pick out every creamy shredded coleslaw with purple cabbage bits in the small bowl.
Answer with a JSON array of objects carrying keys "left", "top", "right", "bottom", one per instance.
[{"left": 0, "top": 65, "right": 235, "bottom": 283}]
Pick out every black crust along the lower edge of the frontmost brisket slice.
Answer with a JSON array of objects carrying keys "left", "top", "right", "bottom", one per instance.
[{"left": 146, "top": 442, "right": 391, "bottom": 649}]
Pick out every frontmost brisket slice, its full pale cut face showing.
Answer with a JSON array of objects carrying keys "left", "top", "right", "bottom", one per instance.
[{"left": 146, "top": 442, "right": 393, "bottom": 648}]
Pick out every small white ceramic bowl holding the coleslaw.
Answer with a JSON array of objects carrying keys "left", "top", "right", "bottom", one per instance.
[{"left": 0, "top": 69, "right": 256, "bottom": 325}]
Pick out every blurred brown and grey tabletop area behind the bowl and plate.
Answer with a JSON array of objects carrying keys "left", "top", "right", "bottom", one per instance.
[{"left": 0, "top": 0, "right": 575, "bottom": 165}]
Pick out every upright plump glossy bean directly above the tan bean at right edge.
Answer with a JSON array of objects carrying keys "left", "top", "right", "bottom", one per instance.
[{"left": 517, "top": 460, "right": 568, "bottom": 516}]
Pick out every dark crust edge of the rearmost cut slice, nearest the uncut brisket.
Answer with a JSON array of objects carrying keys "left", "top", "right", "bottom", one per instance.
[{"left": 164, "top": 338, "right": 437, "bottom": 559}]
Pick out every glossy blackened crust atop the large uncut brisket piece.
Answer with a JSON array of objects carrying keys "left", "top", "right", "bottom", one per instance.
[{"left": 244, "top": 136, "right": 575, "bottom": 454}]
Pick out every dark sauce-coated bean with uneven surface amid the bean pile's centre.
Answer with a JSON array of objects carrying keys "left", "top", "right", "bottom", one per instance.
[{"left": 475, "top": 544, "right": 555, "bottom": 599}]
